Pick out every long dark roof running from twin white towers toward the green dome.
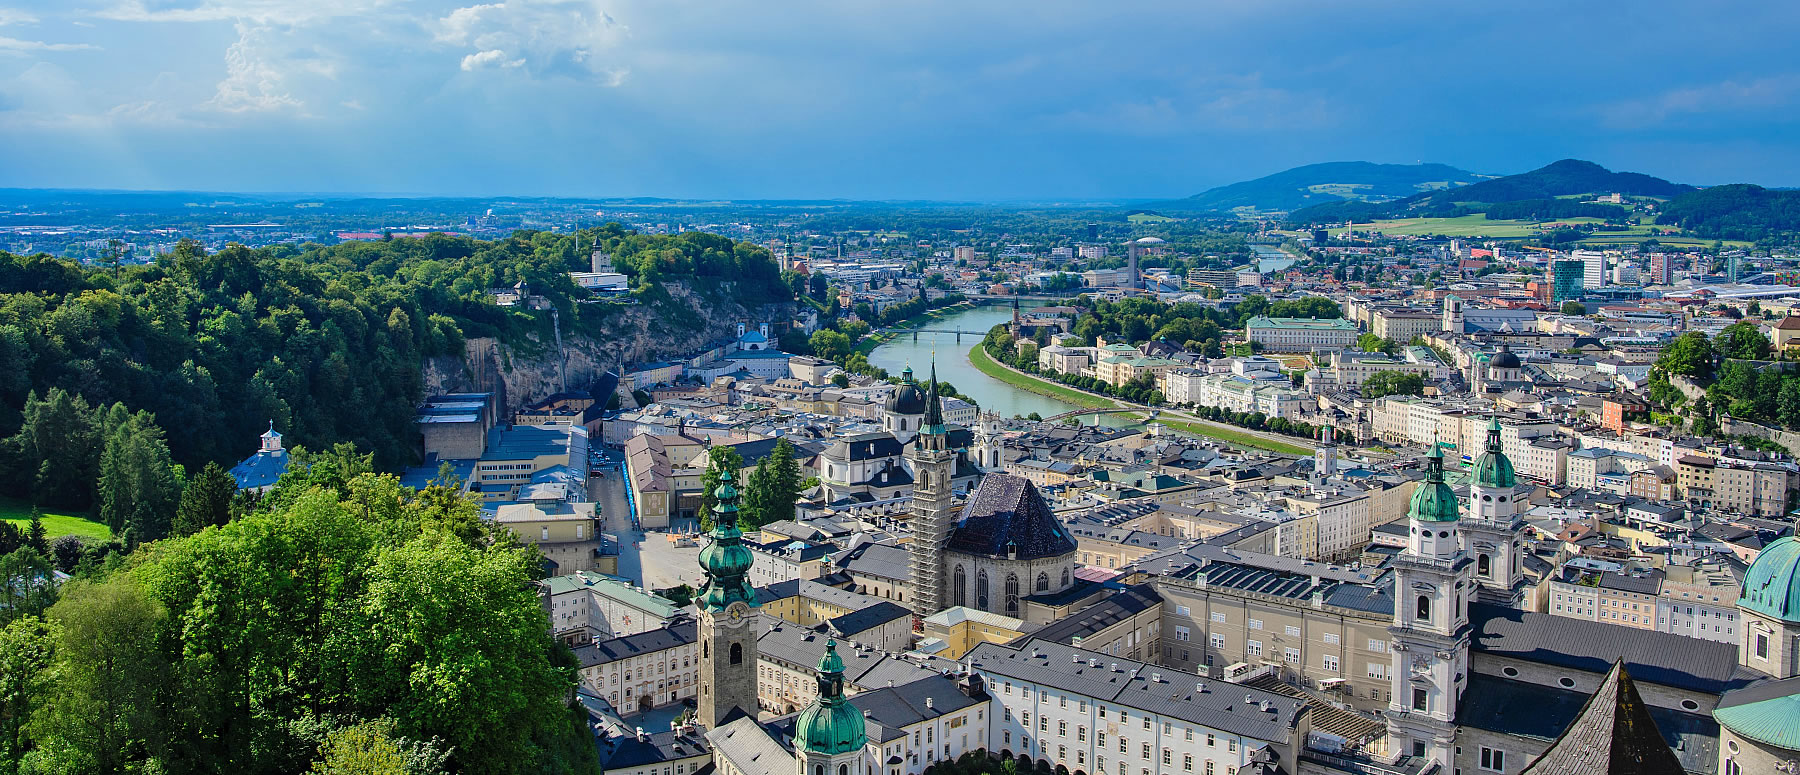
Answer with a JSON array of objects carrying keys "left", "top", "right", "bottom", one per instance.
[{"left": 1469, "top": 602, "right": 1748, "bottom": 694}]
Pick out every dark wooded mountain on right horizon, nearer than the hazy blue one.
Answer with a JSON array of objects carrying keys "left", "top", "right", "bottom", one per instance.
[{"left": 1287, "top": 158, "right": 1696, "bottom": 225}]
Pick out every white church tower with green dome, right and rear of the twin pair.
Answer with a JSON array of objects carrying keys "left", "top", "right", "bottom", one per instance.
[{"left": 1463, "top": 417, "right": 1525, "bottom": 608}]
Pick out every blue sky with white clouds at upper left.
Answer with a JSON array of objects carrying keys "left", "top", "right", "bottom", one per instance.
[{"left": 0, "top": 0, "right": 1800, "bottom": 201}]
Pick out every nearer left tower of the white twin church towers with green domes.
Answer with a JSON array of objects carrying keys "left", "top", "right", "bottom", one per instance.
[{"left": 1386, "top": 444, "right": 1474, "bottom": 770}]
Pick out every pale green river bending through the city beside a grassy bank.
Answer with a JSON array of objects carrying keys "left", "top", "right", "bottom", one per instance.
[{"left": 869, "top": 302, "right": 1136, "bottom": 428}]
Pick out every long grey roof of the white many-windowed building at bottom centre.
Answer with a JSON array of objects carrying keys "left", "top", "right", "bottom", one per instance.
[{"left": 965, "top": 640, "right": 1307, "bottom": 743}]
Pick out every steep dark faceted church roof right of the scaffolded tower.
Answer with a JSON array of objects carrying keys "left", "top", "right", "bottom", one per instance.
[{"left": 947, "top": 473, "right": 1075, "bottom": 559}]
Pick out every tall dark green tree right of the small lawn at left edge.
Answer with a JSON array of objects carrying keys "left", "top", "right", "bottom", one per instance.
[{"left": 97, "top": 403, "right": 182, "bottom": 541}]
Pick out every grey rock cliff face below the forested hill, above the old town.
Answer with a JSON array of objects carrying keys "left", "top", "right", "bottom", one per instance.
[{"left": 425, "top": 282, "right": 794, "bottom": 410}]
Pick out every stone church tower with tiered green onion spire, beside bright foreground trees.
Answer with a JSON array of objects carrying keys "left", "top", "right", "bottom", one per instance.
[{"left": 695, "top": 469, "right": 761, "bottom": 728}]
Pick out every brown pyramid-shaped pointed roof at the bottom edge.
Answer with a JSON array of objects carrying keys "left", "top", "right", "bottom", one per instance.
[{"left": 1521, "top": 662, "right": 1692, "bottom": 775}]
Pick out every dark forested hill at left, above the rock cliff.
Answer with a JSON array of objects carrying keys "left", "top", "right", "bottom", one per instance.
[{"left": 0, "top": 225, "right": 792, "bottom": 474}]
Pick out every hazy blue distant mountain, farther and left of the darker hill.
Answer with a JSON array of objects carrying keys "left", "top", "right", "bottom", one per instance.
[{"left": 1174, "top": 162, "right": 1481, "bottom": 210}]
